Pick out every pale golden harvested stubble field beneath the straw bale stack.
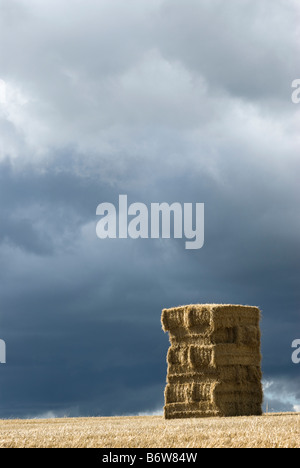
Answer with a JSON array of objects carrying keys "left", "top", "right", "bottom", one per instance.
[{"left": 0, "top": 413, "right": 300, "bottom": 448}]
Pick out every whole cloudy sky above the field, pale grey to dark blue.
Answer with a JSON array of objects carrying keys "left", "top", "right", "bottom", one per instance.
[{"left": 0, "top": 0, "right": 300, "bottom": 418}]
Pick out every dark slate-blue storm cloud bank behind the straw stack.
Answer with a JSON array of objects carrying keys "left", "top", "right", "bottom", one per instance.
[{"left": 1, "top": 152, "right": 299, "bottom": 417}]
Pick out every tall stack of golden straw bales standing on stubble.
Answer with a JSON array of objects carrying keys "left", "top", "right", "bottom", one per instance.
[{"left": 162, "top": 304, "right": 263, "bottom": 419}]
